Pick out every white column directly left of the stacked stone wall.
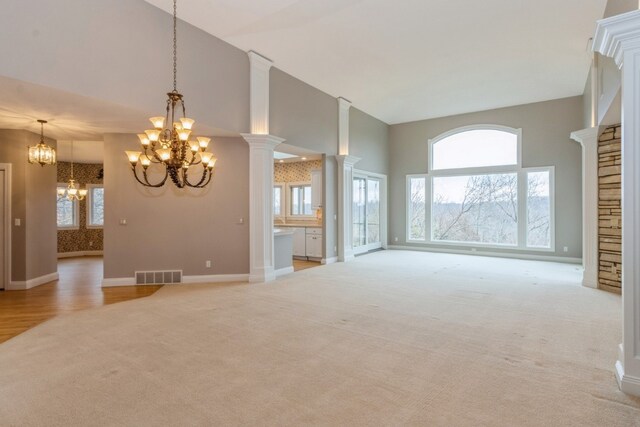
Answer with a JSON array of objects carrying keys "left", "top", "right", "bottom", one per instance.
[{"left": 571, "top": 127, "right": 600, "bottom": 289}]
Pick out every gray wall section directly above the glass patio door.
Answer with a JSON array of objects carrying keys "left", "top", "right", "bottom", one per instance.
[{"left": 349, "top": 107, "right": 389, "bottom": 175}]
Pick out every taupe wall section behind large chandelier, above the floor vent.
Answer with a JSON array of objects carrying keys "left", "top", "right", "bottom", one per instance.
[{"left": 104, "top": 134, "right": 249, "bottom": 278}]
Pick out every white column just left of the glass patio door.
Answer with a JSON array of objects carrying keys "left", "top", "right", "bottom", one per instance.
[{"left": 336, "top": 155, "right": 360, "bottom": 262}]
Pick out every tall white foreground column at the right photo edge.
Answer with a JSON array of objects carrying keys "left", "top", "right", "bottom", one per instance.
[{"left": 593, "top": 11, "right": 640, "bottom": 396}]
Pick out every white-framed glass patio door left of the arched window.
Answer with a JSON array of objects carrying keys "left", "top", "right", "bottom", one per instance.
[{"left": 353, "top": 172, "right": 386, "bottom": 255}]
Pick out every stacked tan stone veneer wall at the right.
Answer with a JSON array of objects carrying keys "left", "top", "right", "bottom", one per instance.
[{"left": 598, "top": 124, "right": 622, "bottom": 293}]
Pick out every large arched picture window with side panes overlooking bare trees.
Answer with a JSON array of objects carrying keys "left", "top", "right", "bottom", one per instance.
[{"left": 407, "top": 126, "right": 554, "bottom": 250}]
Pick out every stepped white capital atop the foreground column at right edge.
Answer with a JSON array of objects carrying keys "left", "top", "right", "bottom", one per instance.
[{"left": 593, "top": 10, "right": 640, "bottom": 68}]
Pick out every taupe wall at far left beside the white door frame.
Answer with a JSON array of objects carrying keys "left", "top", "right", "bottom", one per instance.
[{"left": 0, "top": 129, "right": 57, "bottom": 282}]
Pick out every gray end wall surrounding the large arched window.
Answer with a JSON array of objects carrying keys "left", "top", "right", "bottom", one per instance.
[{"left": 389, "top": 96, "right": 583, "bottom": 258}]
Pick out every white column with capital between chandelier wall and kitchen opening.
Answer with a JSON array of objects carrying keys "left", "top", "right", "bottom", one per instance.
[{"left": 242, "top": 134, "right": 284, "bottom": 282}]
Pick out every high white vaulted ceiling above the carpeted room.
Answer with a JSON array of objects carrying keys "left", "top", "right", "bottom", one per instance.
[{"left": 146, "top": 0, "right": 606, "bottom": 124}]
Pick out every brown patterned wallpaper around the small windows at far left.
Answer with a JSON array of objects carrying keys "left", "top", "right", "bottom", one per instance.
[{"left": 57, "top": 162, "right": 103, "bottom": 253}]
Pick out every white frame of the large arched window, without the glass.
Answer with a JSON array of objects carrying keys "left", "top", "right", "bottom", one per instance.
[{"left": 405, "top": 125, "right": 556, "bottom": 252}]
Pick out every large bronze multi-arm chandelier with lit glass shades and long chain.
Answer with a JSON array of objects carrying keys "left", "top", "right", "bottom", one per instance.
[{"left": 125, "top": 0, "right": 217, "bottom": 188}]
